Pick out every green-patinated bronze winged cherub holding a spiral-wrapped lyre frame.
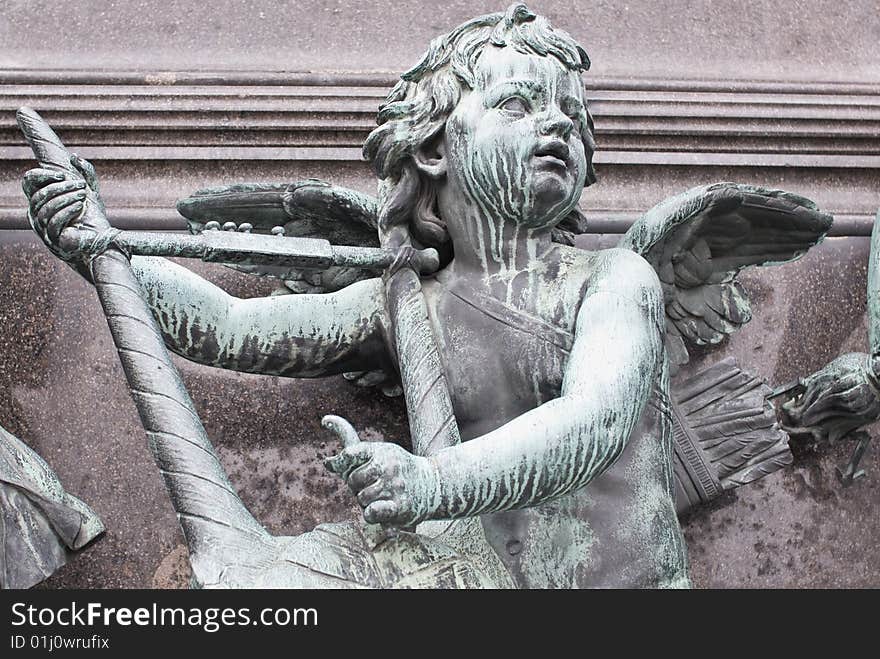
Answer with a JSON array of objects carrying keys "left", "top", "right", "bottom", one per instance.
[{"left": 20, "top": 4, "right": 832, "bottom": 588}]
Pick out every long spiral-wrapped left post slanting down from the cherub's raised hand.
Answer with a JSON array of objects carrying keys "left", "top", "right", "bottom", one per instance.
[{"left": 17, "top": 108, "right": 271, "bottom": 583}]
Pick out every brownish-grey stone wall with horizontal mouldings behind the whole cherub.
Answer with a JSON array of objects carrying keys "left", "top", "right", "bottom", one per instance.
[{"left": 0, "top": 0, "right": 880, "bottom": 587}]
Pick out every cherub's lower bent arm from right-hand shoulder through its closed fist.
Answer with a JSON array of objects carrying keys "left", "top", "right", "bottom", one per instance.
[{"left": 329, "top": 250, "right": 664, "bottom": 524}]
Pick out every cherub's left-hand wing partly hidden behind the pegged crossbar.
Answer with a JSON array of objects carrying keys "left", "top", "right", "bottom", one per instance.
[{"left": 177, "top": 179, "right": 379, "bottom": 293}]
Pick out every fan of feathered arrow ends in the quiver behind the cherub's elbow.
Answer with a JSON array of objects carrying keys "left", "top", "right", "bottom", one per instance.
[{"left": 672, "top": 358, "right": 792, "bottom": 514}]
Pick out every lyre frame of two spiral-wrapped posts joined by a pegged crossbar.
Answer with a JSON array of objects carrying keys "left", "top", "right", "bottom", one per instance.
[{"left": 18, "top": 108, "right": 461, "bottom": 553}]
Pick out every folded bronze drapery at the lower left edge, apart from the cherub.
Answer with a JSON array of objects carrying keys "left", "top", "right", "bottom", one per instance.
[{"left": 0, "top": 428, "right": 104, "bottom": 588}]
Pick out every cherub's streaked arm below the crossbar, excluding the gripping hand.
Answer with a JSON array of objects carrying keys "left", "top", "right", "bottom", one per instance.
[{"left": 131, "top": 257, "right": 386, "bottom": 377}]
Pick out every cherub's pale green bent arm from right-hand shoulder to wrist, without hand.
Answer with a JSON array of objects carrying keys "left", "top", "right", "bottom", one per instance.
[{"left": 431, "top": 250, "right": 664, "bottom": 518}]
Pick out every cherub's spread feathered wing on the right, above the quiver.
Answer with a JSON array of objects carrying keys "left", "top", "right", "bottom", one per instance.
[{"left": 618, "top": 183, "right": 832, "bottom": 369}]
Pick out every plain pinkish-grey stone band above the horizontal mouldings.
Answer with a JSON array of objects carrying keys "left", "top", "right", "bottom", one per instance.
[{"left": 0, "top": 0, "right": 880, "bottom": 82}]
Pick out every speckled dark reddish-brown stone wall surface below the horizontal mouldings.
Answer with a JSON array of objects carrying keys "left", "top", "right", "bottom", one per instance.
[{"left": 0, "top": 232, "right": 880, "bottom": 588}]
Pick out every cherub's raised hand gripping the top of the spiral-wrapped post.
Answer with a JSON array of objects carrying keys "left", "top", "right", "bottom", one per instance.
[{"left": 22, "top": 155, "right": 110, "bottom": 263}]
